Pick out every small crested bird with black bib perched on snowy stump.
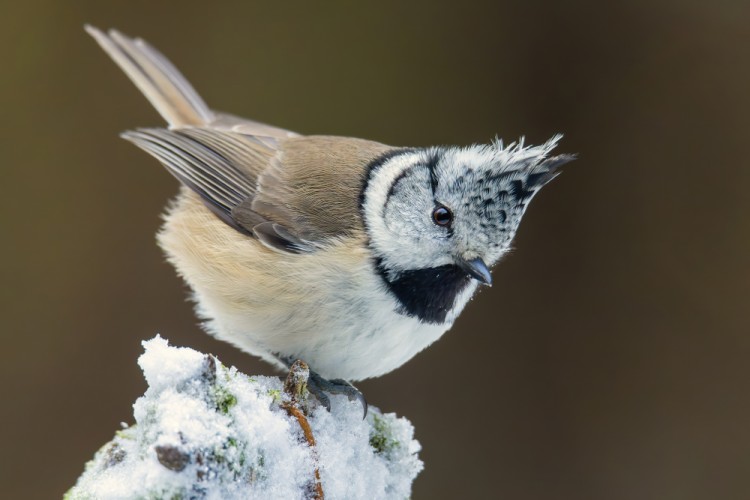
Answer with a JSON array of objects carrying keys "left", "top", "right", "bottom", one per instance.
[{"left": 85, "top": 26, "right": 575, "bottom": 414}]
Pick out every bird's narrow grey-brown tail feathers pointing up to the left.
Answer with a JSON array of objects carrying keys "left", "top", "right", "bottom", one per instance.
[{"left": 86, "top": 25, "right": 215, "bottom": 128}]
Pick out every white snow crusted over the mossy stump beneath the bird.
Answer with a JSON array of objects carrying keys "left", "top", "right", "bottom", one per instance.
[{"left": 65, "top": 336, "right": 422, "bottom": 500}]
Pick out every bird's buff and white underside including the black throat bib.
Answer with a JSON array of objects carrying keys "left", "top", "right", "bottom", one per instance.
[{"left": 159, "top": 195, "right": 475, "bottom": 380}]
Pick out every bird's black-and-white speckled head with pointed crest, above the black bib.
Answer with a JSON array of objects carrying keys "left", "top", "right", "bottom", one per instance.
[{"left": 362, "top": 136, "right": 574, "bottom": 298}]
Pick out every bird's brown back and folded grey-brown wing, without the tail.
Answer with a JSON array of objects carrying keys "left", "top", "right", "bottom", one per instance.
[{"left": 123, "top": 127, "right": 400, "bottom": 253}]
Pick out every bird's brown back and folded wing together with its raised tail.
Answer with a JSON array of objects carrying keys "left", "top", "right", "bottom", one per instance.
[{"left": 86, "top": 26, "right": 400, "bottom": 252}]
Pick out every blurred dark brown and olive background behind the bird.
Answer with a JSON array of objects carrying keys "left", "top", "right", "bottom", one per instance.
[{"left": 0, "top": 0, "right": 750, "bottom": 500}]
